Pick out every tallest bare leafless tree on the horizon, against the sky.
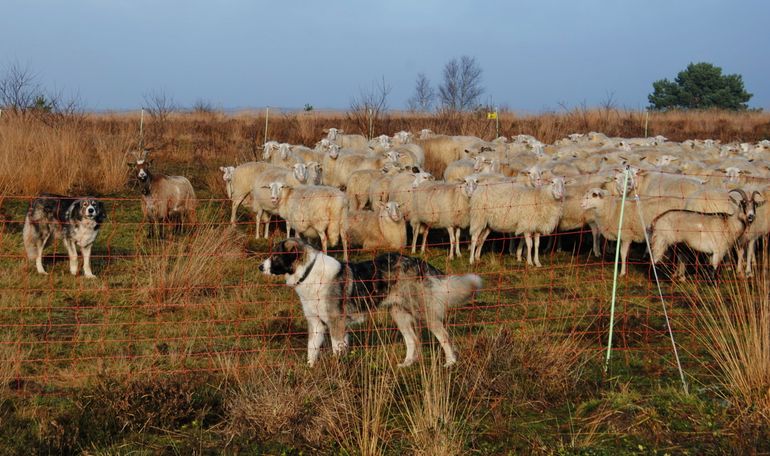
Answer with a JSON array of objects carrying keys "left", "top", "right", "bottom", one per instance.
[{"left": 438, "top": 55, "right": 484, "bottom": 111}]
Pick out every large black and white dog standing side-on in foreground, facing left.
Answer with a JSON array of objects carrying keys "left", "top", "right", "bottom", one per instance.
[{"left": 259, "top": 238, "right": 482, "bottom": 367}]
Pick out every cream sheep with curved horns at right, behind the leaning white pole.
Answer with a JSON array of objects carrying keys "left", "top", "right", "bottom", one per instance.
[{"left": 650, "top": 189, "right": 764, "bottom": 278}]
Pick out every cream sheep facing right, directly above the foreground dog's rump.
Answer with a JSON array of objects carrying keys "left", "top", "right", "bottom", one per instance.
[{"left": 409, "top": 180, "right": 476, "bottom": 259}]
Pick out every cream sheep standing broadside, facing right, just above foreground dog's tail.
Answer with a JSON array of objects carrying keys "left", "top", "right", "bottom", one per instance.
[{"left": 470, "top": 177, "right": 564, "bottom": 267}]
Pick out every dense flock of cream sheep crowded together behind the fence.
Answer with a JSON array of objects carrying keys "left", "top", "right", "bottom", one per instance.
[{"left": 132, "top": 128, "right": 770, "bottom": 275}]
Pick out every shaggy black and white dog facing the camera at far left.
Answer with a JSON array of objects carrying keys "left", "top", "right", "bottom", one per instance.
[{"left": 23, "top": 193, "right": 107, "bottom": 278}]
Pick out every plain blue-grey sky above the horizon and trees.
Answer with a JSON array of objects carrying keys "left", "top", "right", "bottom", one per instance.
[{"left": 0, "top": 0, "right": 770, "bottom": 112}]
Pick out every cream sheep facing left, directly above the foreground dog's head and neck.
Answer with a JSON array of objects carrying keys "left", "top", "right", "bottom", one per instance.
[{"left": 268, "top": 182, "right": 348, "bottom": 261}]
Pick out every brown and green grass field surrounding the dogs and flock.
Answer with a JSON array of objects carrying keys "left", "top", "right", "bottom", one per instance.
[{"left": 0, "top": 110, "right": 770, "bottom": 455}]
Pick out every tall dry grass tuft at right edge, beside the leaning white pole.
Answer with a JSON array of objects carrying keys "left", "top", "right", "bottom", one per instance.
[{"left": 685, "top": 269, "right": 770, "bottom": 425}]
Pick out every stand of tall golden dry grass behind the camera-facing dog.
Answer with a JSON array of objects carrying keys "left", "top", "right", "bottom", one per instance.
[{"left": 0, "top": 115, "right": 131, "bottom": 196}]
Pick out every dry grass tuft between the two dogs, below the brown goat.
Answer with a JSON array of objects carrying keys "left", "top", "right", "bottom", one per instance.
[{"left": 136, "top": 223, "right": 243, "bottom": 305}]
